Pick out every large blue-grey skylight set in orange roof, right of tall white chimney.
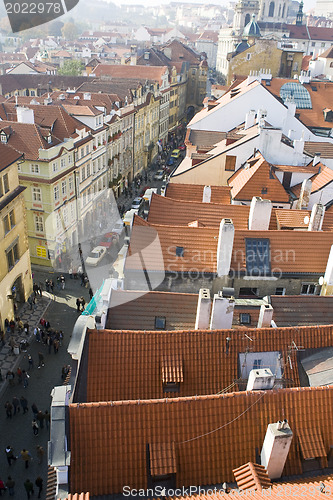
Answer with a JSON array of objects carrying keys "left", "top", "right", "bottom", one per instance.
[{"left": 245, "top": 238, "right": 271, "bottom": 276}]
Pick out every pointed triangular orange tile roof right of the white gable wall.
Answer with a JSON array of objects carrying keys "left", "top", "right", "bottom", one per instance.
[{"left": 228, "top": 155, "right": 289, "bottom": 203}]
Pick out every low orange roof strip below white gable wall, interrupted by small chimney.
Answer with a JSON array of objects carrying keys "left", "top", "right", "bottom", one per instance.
[{"left": 165, "top": 182, "right": 231, "bottom": 205}]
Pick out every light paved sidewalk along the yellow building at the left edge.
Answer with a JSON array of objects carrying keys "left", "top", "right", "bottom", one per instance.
[{"left": 0, "top": 292, "right": 52, "bottom": 397}]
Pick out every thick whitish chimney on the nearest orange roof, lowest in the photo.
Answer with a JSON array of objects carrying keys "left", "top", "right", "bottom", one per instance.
[{"left": 260, "top": 420, "right": 293, "bottom": 479}]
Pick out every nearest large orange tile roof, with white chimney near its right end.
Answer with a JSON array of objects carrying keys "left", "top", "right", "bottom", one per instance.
[{"left": 69, "top": 384, "right": 333, "bottom": 498}]
